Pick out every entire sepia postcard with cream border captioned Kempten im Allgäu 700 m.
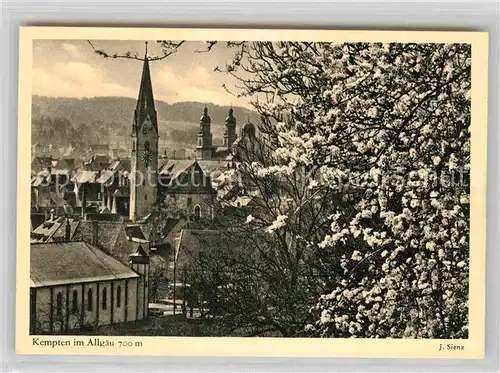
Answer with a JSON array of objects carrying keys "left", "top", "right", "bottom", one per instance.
[{"left": 16, "top": 27, "right": 488, "bottom": 358}]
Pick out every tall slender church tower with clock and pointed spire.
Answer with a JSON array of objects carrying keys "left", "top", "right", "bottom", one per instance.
[{"left": 130, "top": 43, "right": 159, "bottom": 222}]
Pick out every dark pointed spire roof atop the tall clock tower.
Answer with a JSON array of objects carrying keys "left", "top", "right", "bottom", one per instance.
[{"left": 134, "top": 42, "right": 158, "bottom": 133}]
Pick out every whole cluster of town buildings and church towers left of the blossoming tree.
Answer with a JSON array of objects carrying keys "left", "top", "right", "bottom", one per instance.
[{"left": 30, "top": 45, "right": 266, "bottom": 333}]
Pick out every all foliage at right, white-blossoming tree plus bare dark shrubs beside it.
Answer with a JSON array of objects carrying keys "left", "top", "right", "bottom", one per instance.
[{"left": 92, "top": 42, "right": 471, "bottom": 338}]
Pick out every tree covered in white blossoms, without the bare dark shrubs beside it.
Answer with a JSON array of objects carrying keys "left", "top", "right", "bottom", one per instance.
[{"left": 217, "top": 42, "right": 471, "bottom": 338}]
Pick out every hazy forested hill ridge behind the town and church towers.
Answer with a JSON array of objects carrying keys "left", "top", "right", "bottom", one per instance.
[{"left": 32, "top": 96, "right": 259, "bottom": 145}]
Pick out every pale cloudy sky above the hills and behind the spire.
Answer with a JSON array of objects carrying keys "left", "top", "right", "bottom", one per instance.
[{"left": 32, "top": 40, "right": 250, "bottom": 107}]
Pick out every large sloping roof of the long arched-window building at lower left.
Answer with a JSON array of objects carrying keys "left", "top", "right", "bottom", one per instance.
[{"left": 30, "top": 242, "right": 139, "bottom": 287}]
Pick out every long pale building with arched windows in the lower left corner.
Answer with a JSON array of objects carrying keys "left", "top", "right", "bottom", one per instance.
[{"left": 30, "top": 242, "right": 149, "bottom": 334}]
